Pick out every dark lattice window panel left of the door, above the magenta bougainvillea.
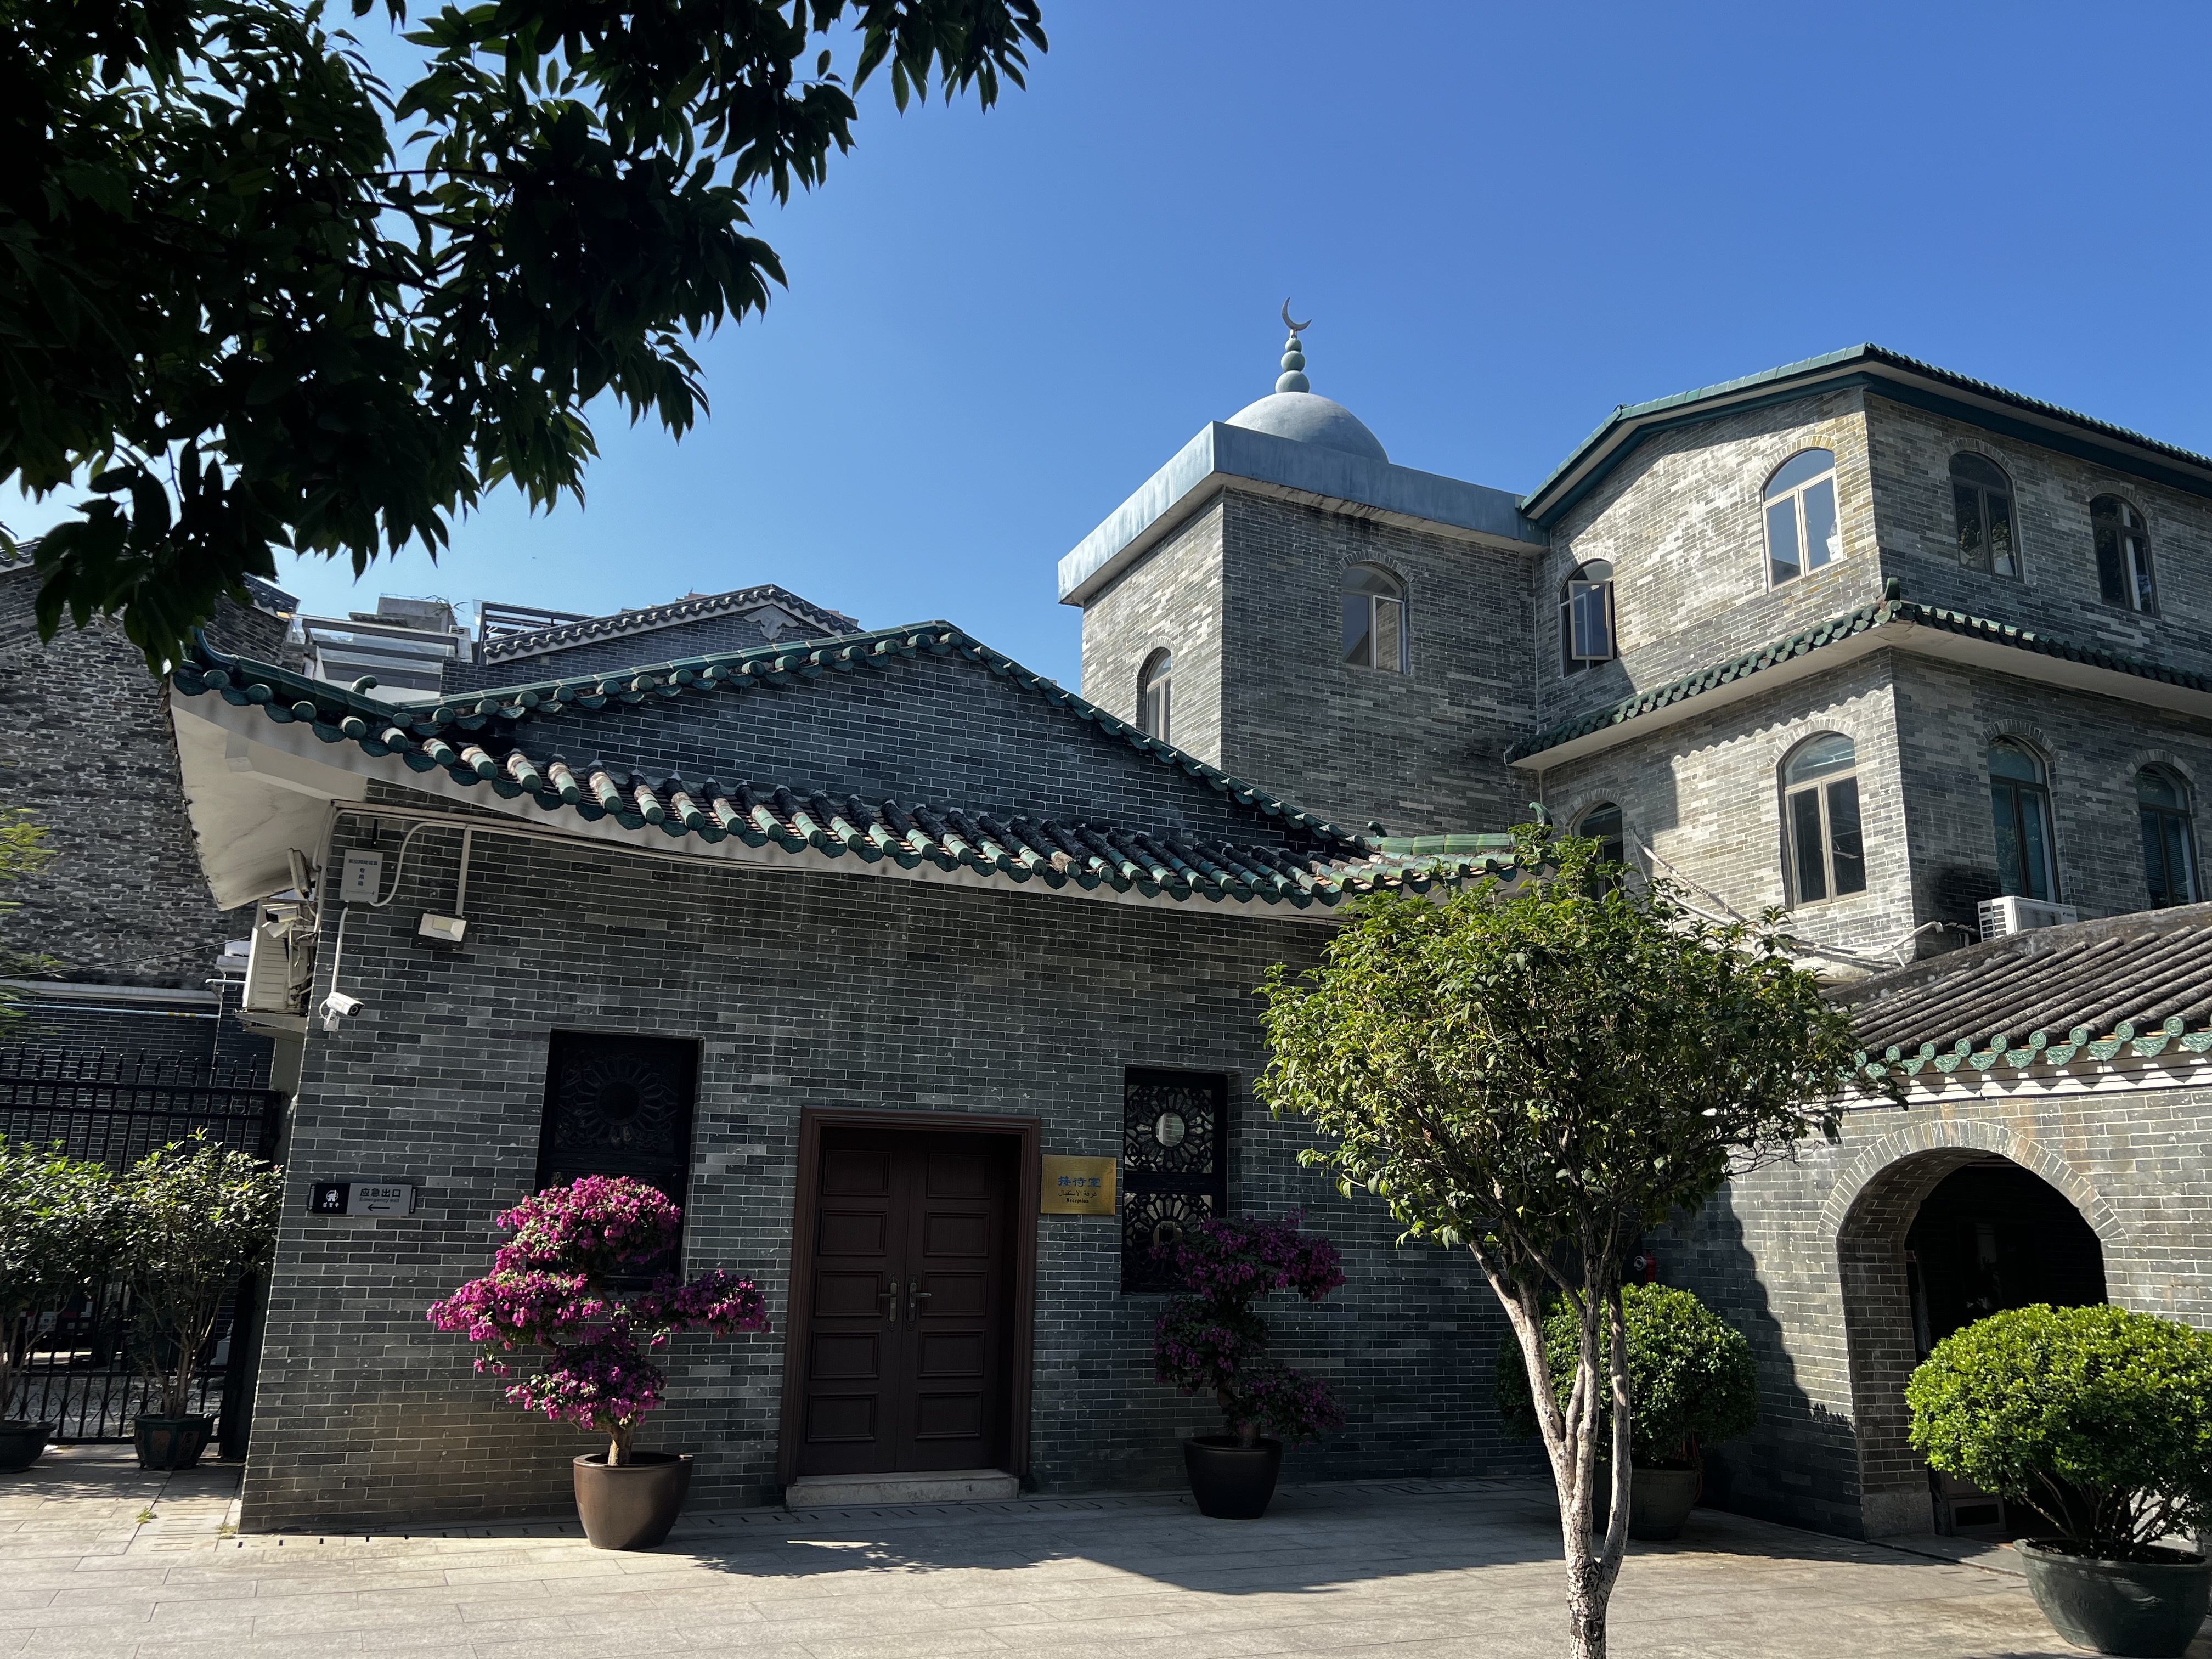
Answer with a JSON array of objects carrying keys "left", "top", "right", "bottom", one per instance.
[{"left": 538, "top": 1031, "right": 699, "bottom": 1269}]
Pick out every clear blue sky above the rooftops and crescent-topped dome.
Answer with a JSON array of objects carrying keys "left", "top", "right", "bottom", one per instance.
[{"left": 7, "top": 0, "right": 2212, "bottom": 684}]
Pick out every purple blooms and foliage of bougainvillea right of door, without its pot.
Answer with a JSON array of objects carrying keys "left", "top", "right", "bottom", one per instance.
[{"left": 1153, "top": 1215, "right": 1345, "bottom": 1444}]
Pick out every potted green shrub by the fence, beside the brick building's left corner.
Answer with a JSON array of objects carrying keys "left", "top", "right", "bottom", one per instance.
[{"left": 120, "top": 1132, "right": 283, "bottom": 1469}]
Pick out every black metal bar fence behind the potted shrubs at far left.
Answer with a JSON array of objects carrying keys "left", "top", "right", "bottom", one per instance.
[{"left": 0, "top": 1048, "right": 283, "bottom": 1455}]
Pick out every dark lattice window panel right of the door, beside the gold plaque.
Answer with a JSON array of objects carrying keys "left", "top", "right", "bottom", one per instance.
[{"left": 1121, "top": 1066, "right": 1230, "bottom": 1292}]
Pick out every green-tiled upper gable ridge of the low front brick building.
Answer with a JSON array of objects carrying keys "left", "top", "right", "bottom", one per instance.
[{"left": 185, "top": 619, "right": 1374, "bottom": 854}]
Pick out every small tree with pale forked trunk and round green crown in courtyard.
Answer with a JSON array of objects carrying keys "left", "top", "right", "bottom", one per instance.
[{"left": 1259, "top": 825, "right": 1863, "bottom": 1659}]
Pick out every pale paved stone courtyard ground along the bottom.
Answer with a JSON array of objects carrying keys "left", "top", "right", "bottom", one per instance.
[{"left": 0, "top": 1447, "right": 2212, "bottom": 1659}]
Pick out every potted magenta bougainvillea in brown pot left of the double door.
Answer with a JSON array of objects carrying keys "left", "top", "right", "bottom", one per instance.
[{"left": 429, "top": 1175, "right": 768, "bottom": 1550}]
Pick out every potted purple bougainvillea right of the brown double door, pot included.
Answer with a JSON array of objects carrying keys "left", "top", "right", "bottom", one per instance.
[{"left": 1153, "top": 1215, "right": 1345, "bottom": 1520}]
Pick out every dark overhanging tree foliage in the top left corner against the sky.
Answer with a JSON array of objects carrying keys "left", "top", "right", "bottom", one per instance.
[{"left": 0, "top": 0, "right": 1046, "bottom": 666}]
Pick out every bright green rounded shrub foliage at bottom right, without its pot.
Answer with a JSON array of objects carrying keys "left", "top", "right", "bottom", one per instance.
[{"left": 1905, "top": 1305, "right": 2212, "bottom": 1562}]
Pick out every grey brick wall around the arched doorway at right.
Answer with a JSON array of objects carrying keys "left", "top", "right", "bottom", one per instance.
[{"left": 1657, "top": 1084, "right": 2212, "bottom": 1535}]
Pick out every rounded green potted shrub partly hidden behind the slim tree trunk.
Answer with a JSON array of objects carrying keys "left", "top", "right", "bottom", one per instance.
[{"left": 1498, "top": 1285, "right": 1758, "bottom": 1539}]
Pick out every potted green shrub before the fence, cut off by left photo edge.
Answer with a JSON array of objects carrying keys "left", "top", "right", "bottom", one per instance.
[{"left": 0, "top": 1137, "right": 115, "bottom": 1471}]
